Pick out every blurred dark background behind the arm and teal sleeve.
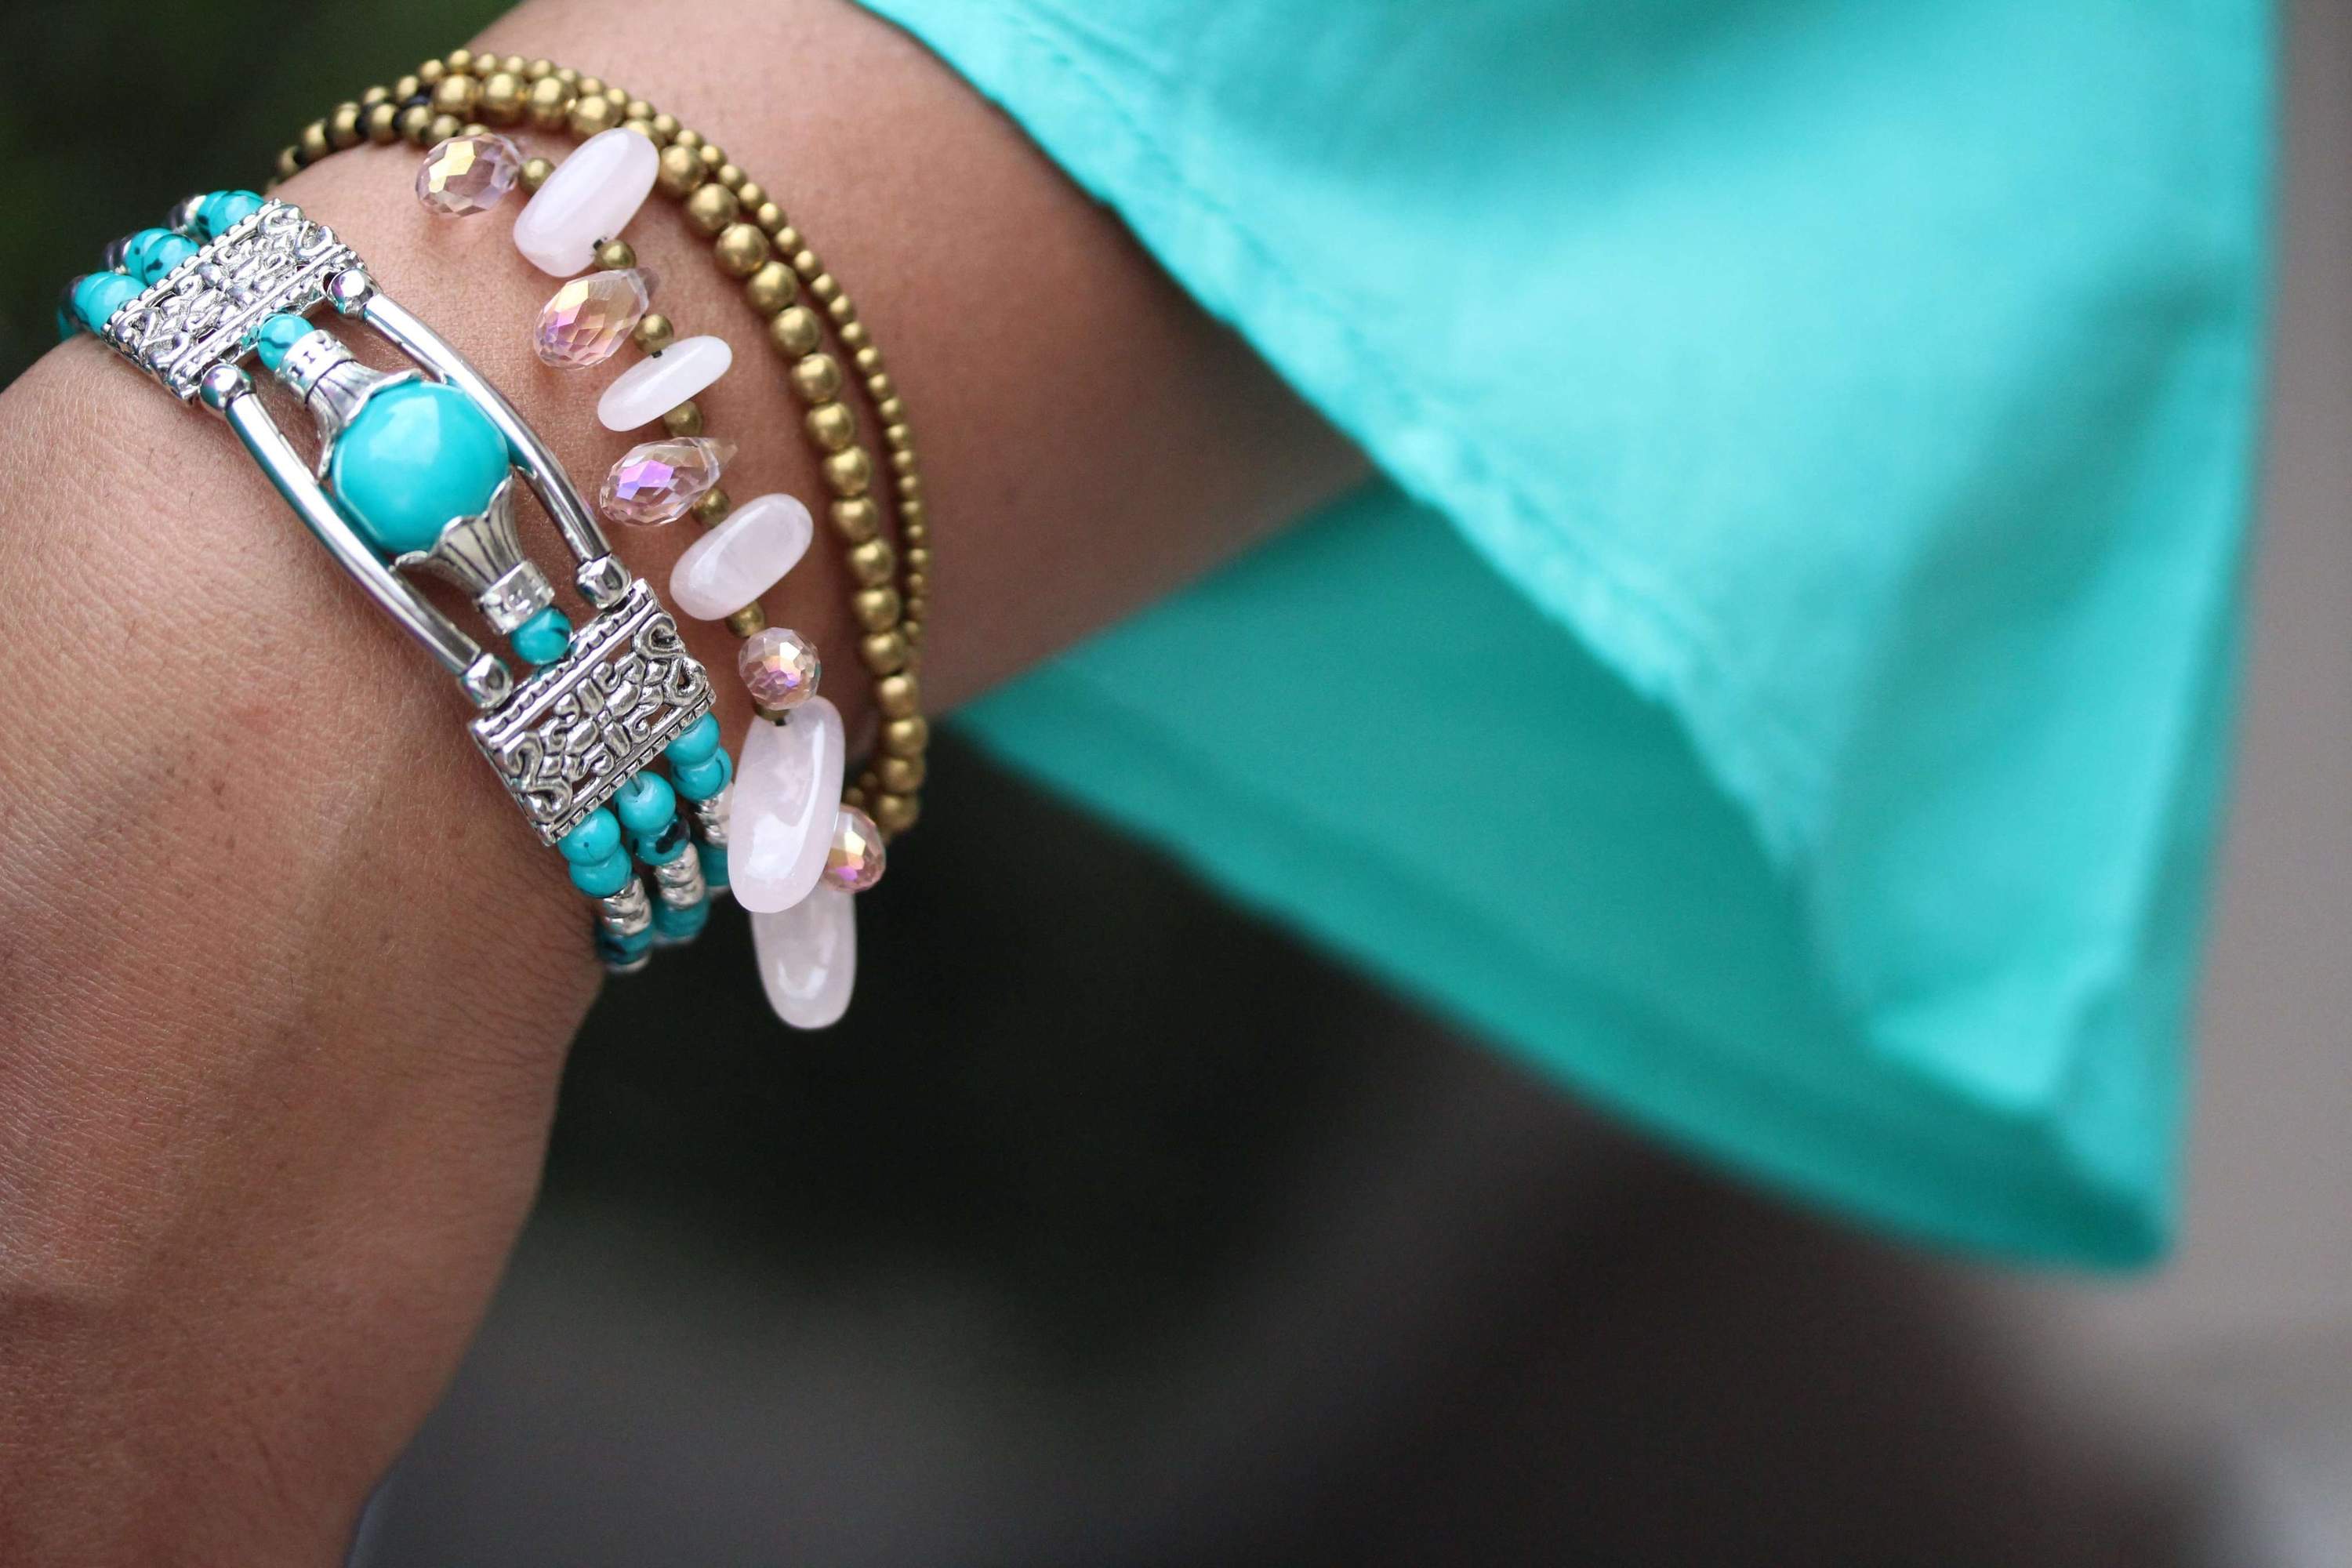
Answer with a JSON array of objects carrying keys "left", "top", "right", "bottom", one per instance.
[{"left": 0, "top": 0, "right": 2352, "bottom": 1568}]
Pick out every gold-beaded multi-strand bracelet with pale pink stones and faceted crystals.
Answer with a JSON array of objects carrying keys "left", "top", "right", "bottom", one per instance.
[{"left": 280, "top": 49, "right": 929, "bottom": 1027}]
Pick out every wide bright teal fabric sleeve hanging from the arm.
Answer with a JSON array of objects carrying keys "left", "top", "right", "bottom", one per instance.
[{"left": 868, "top": 0, "right": 2270, "bottom": 1265}]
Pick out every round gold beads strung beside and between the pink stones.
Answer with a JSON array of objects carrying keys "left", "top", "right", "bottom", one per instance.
[{"left": 278, "top": 49, "right": 931, "bottom": 837}]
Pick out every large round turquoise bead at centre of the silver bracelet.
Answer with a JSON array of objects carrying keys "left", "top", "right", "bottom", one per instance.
[{"left": 327, "top": 381, "right": 506, "bottom": 555}]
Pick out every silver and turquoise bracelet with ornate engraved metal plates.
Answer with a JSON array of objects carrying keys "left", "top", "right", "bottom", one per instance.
[{"left": 68, "top": 191, "right": 717, "bottom": 968}]
